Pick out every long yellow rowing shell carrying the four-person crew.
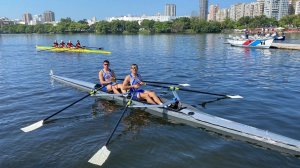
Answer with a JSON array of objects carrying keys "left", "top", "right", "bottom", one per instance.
[{"left": 36, "top": 45, "right": 111, "bottom": 54}]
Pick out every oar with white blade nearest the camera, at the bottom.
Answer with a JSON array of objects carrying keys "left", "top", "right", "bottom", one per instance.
[{"left": 89, "top": 96, "right": 133, "bottom": 166}]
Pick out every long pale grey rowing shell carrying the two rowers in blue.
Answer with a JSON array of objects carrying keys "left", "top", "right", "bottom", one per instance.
[{"left": 50, "top": 73, "right": 300, "bottom": 156}]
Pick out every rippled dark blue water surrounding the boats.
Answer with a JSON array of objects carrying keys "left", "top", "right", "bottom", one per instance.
[{"left": 0, "top": 34, "right": 300, "bottom": 168}]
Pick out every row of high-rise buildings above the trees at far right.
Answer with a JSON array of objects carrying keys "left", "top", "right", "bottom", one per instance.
[{"left": 199, "top": 0, "right": 300, "bottom": 22}]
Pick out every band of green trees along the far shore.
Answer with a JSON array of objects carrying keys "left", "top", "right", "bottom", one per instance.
[{"left": 0, "top": 15, "right": 300, "bottom": 34}]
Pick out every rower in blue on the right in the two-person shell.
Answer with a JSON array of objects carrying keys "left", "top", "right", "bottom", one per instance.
[{"left": 123, "top": 64, "right": 163, "bottom": 104}]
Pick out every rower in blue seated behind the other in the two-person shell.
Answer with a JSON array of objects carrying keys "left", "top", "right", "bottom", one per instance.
[{"left": 99, "top": 60, "right": 126, "bottom": 94}]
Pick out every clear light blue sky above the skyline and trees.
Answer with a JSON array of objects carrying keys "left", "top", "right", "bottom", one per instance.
[{"left": 0, "top": 0, "right": 256, "bottom": 21}]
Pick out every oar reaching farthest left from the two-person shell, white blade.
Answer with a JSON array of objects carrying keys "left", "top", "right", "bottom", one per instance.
[{"left": 21, "top": 85, "right": 103, "bottom": 132}]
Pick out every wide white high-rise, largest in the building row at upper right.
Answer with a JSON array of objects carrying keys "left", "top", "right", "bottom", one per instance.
[{"left": 264, "top": 0, "right": 289, "bottom": 20}]
